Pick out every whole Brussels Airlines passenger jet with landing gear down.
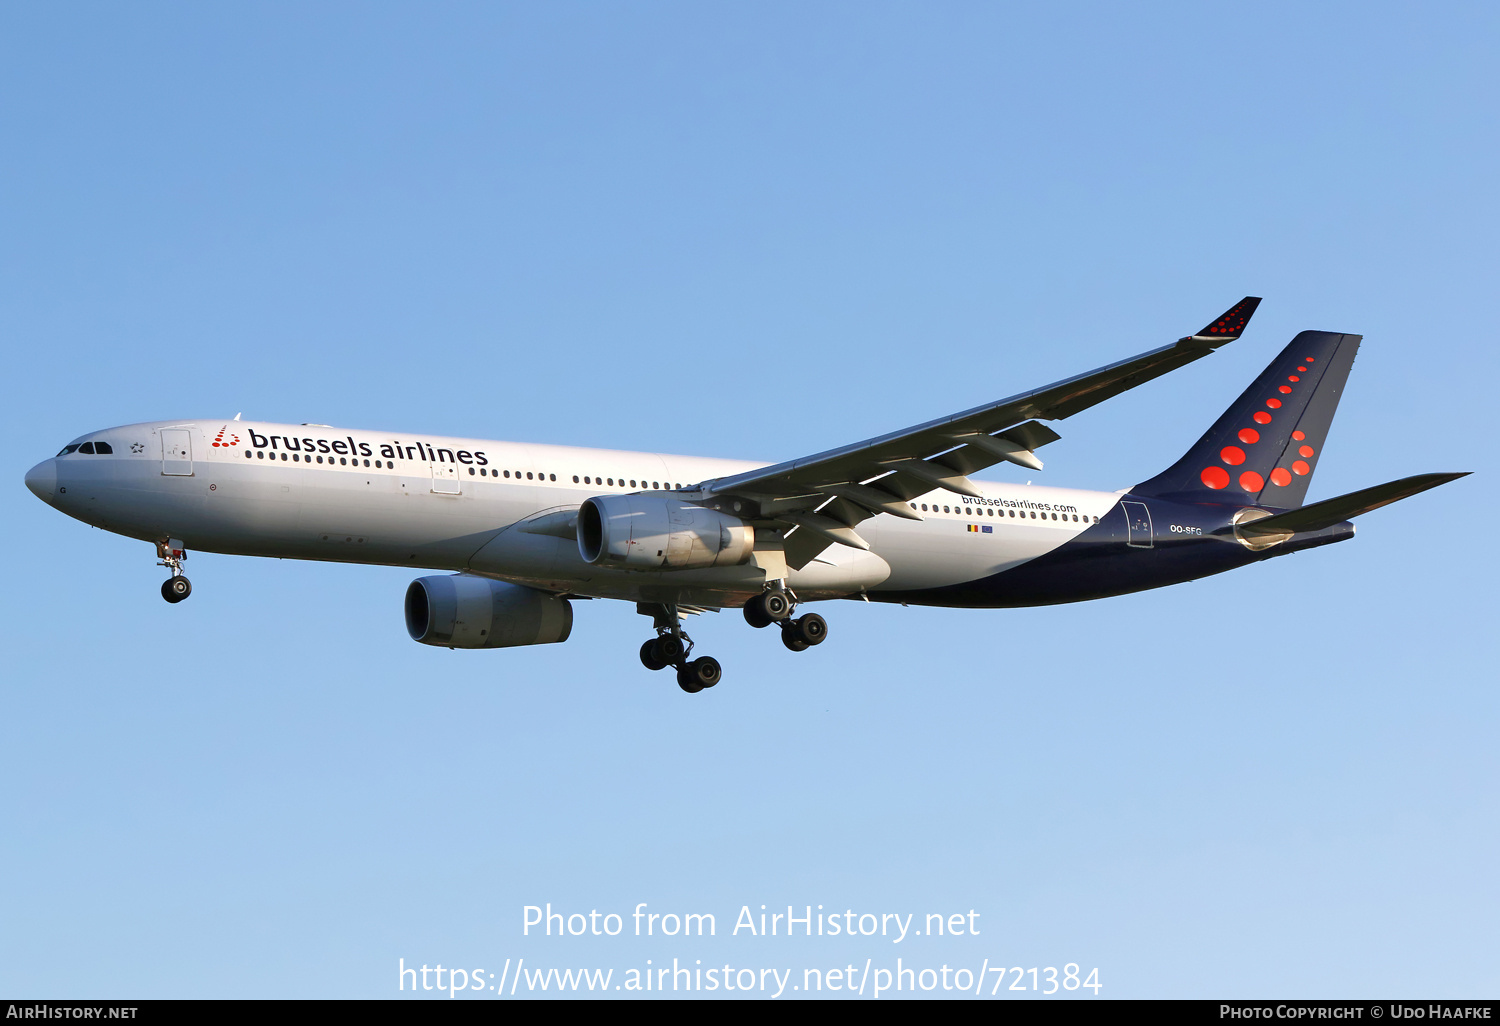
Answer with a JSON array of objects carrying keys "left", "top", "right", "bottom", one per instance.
[{"left": 26, "top": 296, "right": 1466, "bottom": 695}]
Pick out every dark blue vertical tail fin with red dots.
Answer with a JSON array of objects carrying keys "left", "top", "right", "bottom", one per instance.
[{"left": 1131, "top": 332, "right": 1362, "bottom": 509}]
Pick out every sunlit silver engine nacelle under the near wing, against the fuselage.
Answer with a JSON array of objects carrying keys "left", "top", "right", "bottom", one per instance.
[{"left": 578, "top": 492, "right": 755, "bottom": 570}]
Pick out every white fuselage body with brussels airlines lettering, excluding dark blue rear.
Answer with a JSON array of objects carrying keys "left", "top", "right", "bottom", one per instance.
[{"left": 29, "top": 422, "right": 1119, "bottom": 606}]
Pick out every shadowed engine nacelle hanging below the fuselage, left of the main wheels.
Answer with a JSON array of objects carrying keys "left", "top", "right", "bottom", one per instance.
[{"left": 407, "top": 573, "right": 573, "bottom": 648}]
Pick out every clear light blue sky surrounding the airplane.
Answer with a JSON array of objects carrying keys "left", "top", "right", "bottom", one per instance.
[{"left": 0, "top": 3, "right": 1500, "bottom": 998}]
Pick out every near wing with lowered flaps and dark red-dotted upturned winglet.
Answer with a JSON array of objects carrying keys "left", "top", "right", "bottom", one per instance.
[{"left": 696, "top": 296, "right": 1260, "bottom": 569}]
